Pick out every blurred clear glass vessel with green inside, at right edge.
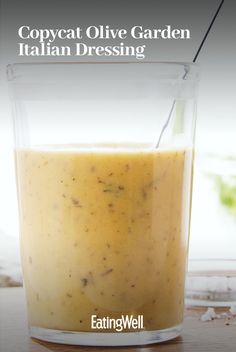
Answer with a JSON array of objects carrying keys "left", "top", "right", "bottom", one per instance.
[{"left": 186, "top": 153, "right": 236, "bottom": 307}]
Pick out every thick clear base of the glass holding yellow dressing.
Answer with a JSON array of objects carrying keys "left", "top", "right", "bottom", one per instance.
[{"left": 30, "top": 325, "right": 182, "bottom": 346}]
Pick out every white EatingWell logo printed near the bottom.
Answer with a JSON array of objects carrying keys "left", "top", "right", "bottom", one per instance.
[{"left": 91, "top": 315, "right": 144, "bottom": 332}]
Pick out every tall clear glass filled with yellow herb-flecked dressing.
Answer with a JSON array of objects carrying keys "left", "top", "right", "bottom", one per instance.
[{"left": 8, "top": 63, "right": 198, "bottom": 345}]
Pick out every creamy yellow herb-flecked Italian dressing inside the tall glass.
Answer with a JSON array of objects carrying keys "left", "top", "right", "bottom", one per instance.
[{"left": 16, "top": 147, "right": 191, "bottom": 331}]
